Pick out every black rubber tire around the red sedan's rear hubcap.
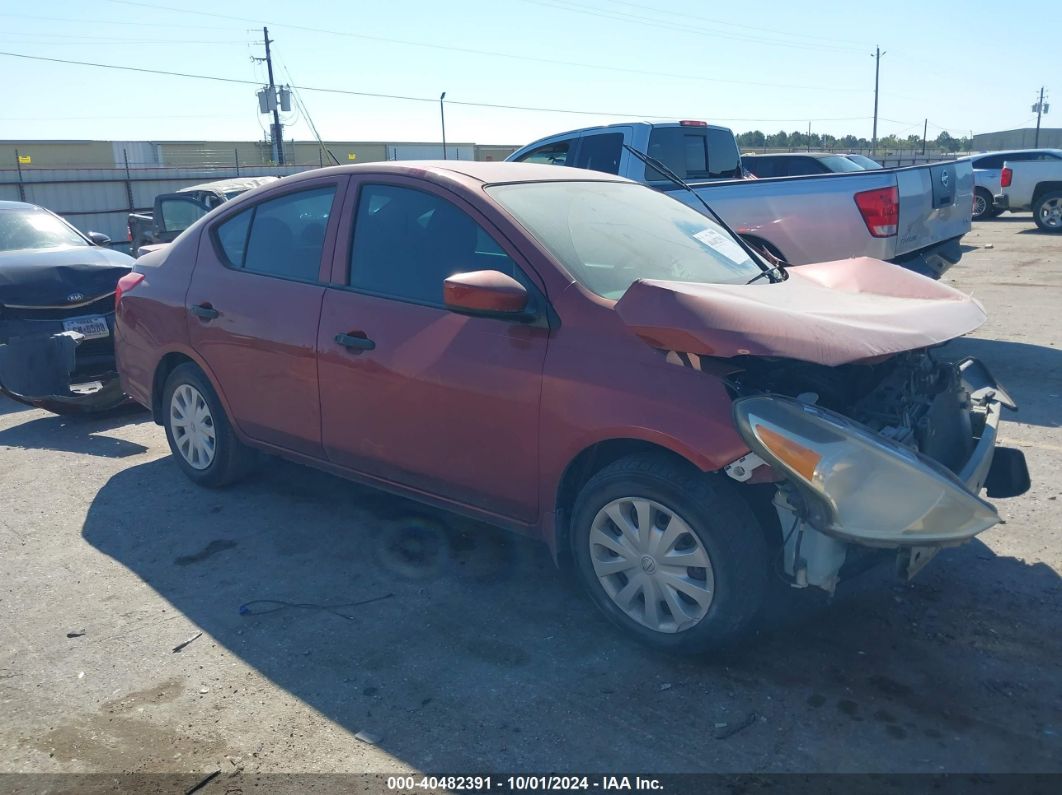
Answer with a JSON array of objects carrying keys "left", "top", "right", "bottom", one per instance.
[{"left": 161, "top": 362, "right": 256, "bottom": 488}]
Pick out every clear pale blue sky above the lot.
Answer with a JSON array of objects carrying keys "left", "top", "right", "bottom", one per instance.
[{"left": 0, "top": 0, "right": 1062, "bottom": 143}]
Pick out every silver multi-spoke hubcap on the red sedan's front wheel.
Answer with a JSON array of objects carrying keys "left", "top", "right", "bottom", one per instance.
[{"left": 589, "top": 497, "right": 715, "bottom": 633}]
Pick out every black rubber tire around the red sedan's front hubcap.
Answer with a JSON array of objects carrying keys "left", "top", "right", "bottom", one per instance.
[{"left": 570, "top": 453, "right": 770, "bottom": 654}]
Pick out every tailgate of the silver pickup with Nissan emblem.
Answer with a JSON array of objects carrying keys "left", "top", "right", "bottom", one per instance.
[{"left": 895, "top": 160, "right": 974, "bottom": 256}]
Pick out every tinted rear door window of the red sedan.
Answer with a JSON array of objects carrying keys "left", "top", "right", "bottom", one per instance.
[{"left": 216, "top": 185, "right": 336, "bottom": 281}]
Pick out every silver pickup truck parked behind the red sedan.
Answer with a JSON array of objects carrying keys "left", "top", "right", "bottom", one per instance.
[{"left": 507, "top": 121, "right": 974, "bottom": 278}]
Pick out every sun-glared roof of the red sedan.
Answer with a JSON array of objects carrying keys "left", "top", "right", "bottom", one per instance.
[{"left": 282, "top": 160, "right": 632, "bottom": 185}]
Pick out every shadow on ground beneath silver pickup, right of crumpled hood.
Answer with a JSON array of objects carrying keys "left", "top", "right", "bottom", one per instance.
[{"left": 939, "top": 336, "right": 1062, "bottom": 428}]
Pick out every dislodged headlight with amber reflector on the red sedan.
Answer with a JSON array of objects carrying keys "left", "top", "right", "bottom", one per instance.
[{"left": 734, "top": 396, "right": 999, "bottom": 546}]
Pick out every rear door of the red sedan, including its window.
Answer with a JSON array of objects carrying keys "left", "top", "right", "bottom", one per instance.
[{"left": 187, "top": 176, "right": 346, "bottom": 457}]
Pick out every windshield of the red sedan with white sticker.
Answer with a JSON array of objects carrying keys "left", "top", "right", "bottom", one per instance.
[{"left": 487, "top": 182, "right": 763, "bottom": 299}]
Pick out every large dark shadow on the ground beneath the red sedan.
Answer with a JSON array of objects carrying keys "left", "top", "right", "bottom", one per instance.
[{"left": 83, "top": 459, "right": 1062, "bottom": 772}]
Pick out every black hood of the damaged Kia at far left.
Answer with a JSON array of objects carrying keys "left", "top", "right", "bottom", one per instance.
[{"left": 0, "top": 246, "right": 135, "bottom": 307}]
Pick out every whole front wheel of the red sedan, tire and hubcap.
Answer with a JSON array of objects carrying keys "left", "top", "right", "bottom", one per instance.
[{"left": 571, "top": 454, "right": 768, "bottom": 653}]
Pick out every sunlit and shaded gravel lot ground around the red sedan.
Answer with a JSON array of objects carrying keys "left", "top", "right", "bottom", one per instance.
[{"left": 0, "top": 215, "right": 1062, "bottom": 776}]
